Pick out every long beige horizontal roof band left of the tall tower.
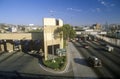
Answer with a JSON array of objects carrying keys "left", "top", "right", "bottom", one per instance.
[{"left": 0, "top": 32, "right": 43, "bottom": 40}]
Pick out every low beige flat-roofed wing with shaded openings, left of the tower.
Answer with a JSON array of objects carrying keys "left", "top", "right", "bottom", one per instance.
[{"left": 0, "top": 32, "right": 43, "bottom": 52}]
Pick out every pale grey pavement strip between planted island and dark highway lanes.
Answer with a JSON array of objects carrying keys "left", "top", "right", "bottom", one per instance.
[{"left": 70, "top": 43, "right": 98, "bottom": 79}]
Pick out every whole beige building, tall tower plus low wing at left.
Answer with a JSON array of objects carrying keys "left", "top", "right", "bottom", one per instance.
[{"left": 0, "top": 18, "right": 63, "bottom": 60}]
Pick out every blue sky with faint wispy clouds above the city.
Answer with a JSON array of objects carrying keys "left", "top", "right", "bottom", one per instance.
[{"left": 0, "top": 0, "right": 120, "bottom": 26}]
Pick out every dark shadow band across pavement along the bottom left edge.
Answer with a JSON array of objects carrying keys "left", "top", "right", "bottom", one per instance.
[{"left": 0, "top": 71, "right": 74, "bottom": 79}]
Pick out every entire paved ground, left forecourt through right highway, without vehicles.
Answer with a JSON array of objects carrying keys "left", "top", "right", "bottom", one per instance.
[{"left": 0, "top": 41, "right": 120, "bottom": 79}]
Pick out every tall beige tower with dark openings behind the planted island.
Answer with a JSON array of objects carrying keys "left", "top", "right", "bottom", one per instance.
[{"left": 43, "top": 18, "right": 63, "bottom": 60}]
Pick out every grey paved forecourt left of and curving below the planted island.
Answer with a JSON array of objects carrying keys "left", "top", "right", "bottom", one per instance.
[{"left": 0, "top": 52, "right": 73, "bottom": 79}]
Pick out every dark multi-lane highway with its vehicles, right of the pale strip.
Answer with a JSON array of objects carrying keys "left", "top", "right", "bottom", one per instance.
[{"left": 73, "top": 36, "right": 120, "bottom": 78}]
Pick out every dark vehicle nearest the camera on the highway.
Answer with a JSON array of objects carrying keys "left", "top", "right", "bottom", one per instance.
[{"left": 88, "top": 56, "right": 102, "bottom": 67}]
